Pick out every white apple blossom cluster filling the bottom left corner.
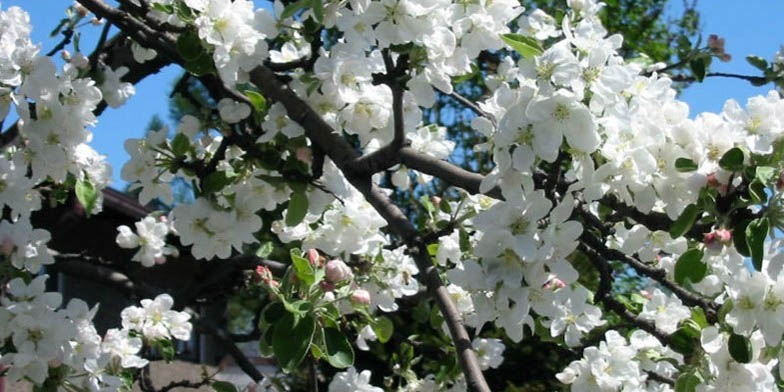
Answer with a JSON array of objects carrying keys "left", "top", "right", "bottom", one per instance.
[{"left": 0, "top": 275, "right": 192, "bottom": 391}]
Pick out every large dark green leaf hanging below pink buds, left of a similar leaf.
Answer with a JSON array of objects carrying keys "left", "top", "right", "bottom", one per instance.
[{"left": 272, "top": 312, "right": 316, "bottom": 373}]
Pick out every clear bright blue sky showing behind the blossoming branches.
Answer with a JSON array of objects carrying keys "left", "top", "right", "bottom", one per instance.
[{"left": 2, "top": 0, "right": 784, "bottom": 187}]
